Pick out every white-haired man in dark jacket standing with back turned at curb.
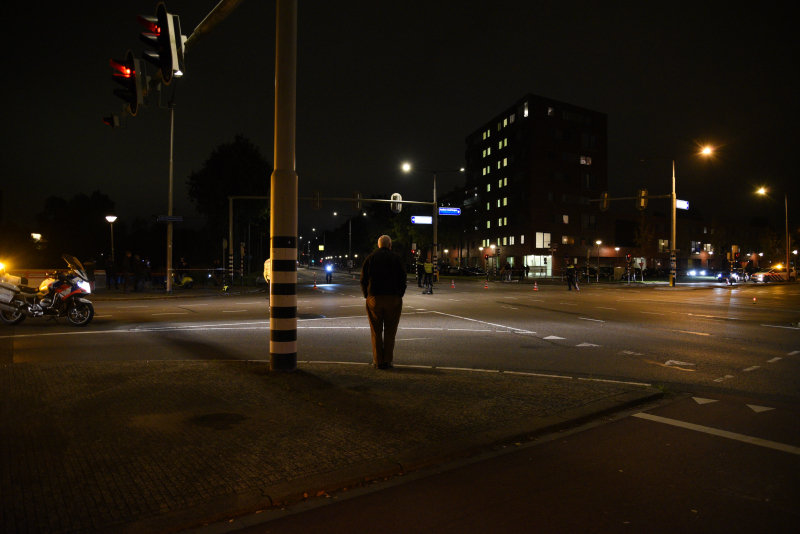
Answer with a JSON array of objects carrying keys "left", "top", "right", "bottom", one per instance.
[{"left": 361, "top": 235, "right": 406, "bottom": 369}]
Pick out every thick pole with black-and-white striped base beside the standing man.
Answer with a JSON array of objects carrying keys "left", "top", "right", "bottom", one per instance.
[{"left": 269, "top": 0, "right": 297, "bottom": 371}]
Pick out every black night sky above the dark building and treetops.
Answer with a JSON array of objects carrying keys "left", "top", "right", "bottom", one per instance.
[{"left": 0, "top": 0, "right": 800, "bottom": 238}]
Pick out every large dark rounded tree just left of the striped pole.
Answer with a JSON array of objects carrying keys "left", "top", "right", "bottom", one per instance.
[{"left": 186, "top": 135, "right": 272, "bottom": 234}]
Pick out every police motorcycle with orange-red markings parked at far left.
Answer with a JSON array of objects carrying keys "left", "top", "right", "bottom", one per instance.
[{"left": 0, "top": 254, "right": 94, "bottom": 326}]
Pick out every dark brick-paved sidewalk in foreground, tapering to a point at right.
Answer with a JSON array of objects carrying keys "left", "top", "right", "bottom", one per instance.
[{"left": 0, "top": 360, "right": 661, "bottom": 533}]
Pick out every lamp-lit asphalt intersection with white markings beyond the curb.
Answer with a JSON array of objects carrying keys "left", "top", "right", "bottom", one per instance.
[{"left": 0, "top": 269, "right": 800, "bottom": 401}]
